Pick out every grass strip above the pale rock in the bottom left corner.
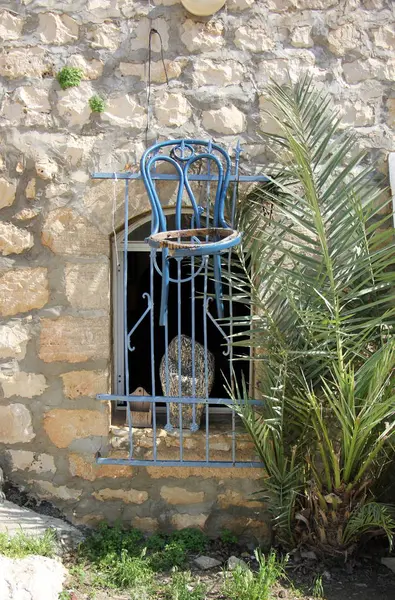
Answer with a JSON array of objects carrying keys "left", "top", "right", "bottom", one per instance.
[{"left": 0, "top": 529, "right": 56, "bottom": 558}]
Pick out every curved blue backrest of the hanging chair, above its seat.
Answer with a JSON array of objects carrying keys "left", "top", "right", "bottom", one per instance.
[{"left": 141, "top": 139, "right": 231, "bottom": 234}]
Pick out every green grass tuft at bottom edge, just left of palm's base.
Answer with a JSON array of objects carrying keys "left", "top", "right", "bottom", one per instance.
[{"left": 224, "top": 550, "right": 286, "bottom": 600}]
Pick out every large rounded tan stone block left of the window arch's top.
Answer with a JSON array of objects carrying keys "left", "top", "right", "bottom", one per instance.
[{"left": 41, "top": 208, "right": 109, "bottom": 256}]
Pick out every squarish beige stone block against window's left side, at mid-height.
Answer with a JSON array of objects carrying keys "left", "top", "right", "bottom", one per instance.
[{"left": 65, "top": 263, "right": 110, "bottom": 310}]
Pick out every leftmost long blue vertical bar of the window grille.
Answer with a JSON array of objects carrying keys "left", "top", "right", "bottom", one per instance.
[{"left": 123, "top": 179, "right": 133, "bottom": 459}]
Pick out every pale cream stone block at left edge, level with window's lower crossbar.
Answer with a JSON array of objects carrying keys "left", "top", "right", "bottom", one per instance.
[{"left": 0, "top": 404, "right": 35, "bottom": 444}]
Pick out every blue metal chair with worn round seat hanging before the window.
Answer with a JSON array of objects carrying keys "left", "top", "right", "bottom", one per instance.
[{"left": 140, "top": 139, "right": 241, "bottom": 326}]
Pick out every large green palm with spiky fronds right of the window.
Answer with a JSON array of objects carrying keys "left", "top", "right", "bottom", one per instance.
[{"left": 233, "top": 77, "right": 395, "bottom": 556}]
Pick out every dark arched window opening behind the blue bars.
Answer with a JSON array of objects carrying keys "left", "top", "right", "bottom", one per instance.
[{"left": 113, "top": 208, "right": 251, "bottom": 426}]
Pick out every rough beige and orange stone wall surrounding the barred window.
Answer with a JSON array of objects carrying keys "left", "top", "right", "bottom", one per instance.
[{"left": 0, "top": 0, "right": 395, "bottom": 538}]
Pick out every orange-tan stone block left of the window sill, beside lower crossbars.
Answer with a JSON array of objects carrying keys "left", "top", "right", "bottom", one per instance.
[{"left": 43, "top": 408, "right": 110, "bottom": 448}]
